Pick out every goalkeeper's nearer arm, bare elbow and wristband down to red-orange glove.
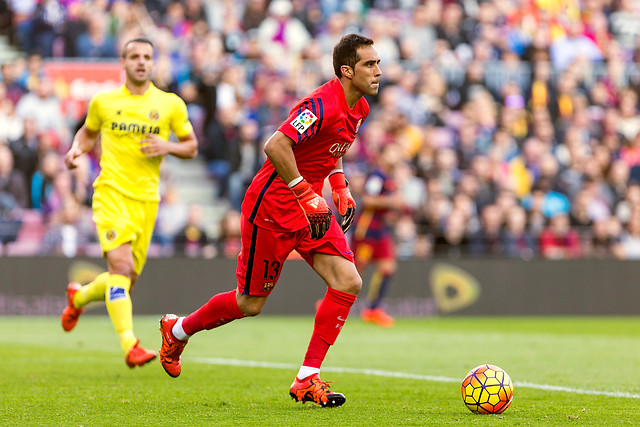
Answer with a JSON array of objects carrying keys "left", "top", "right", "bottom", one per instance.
[{"left": 264, "top": 131, "right": 331, "bottom": 239}]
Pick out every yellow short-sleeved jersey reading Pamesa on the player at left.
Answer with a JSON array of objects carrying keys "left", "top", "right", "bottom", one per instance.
[{"left": 85, "top": 84, "right": 193, "bottom": 201}]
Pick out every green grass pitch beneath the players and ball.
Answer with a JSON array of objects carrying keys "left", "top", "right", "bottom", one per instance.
[{"left": 0, "top": 315, "right": 640, "bottom": 427}]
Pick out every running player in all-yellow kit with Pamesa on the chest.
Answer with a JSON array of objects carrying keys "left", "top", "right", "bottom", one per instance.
[{"left": 61, "top": 38, "right": 198, "bottom": 368}]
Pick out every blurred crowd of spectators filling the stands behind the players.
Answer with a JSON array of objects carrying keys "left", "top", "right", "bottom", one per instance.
[{"left": 0, "top": 0, "right": 640, "bottom": 259}]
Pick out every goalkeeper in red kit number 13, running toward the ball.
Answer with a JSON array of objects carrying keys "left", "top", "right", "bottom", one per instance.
[{"left": 160, "top": 34, "right": 381, "bottom": 407}]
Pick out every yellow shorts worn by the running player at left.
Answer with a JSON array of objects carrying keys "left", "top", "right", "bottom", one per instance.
[{"left": 93, "top": 185, "right": 158, "bottom": 274}]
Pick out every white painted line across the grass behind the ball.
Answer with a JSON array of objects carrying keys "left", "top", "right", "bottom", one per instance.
[{"left": 189, "top": 357, "right": 640, "bottom": 399}]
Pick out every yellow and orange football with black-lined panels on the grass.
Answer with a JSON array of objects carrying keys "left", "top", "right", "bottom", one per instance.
[{"left": 462, "top": 365, "right": 513, "bottom": 414}]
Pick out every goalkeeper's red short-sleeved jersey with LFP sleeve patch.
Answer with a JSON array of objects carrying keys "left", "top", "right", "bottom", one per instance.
[{"left": 242, "top": 79, "right": 369, "bottom": 231}]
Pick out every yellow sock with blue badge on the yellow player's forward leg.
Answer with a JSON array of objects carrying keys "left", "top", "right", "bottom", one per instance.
[{"left": 105, "top": 274, "right": 137, "bottom": 356}]
